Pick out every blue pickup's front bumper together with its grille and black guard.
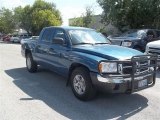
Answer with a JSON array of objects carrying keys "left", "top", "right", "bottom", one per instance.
[{"left": 90, "top": 55, "right": 157, "bottom": 93}]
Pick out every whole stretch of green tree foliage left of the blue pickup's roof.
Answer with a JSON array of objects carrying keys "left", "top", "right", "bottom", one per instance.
[{"left": 0, "top": 0, "right": 62, "bottom": 35}]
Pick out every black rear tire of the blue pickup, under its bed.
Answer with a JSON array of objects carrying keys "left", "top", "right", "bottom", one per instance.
[{"left": 26, "top": 53, "right": 37, "bottom": 73}]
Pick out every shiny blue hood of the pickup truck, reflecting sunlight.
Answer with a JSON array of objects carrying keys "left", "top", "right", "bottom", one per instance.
[{"left": 72, "top": 45, "right": 143, "bottom": 60}]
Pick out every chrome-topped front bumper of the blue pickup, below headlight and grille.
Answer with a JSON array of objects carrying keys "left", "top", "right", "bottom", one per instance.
[{"left": 90, "top": 72, "right": 155, "bottom": 93}]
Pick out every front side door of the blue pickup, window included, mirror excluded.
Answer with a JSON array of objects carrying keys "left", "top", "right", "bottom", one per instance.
[{"left": 49, "top": 28, "right": 70, "bottom": 75}]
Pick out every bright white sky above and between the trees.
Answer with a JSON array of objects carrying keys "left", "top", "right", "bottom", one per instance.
[{"left": 0, "top": 0, "right": 102, "bottom": 26}]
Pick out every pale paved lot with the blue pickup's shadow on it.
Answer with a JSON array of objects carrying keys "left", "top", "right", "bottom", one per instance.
[{"left": 0, "top": 43, "right": 160, "bottom": 120}]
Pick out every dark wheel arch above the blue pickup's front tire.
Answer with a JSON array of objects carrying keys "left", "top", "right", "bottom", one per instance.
[{"left": 67, "top": 63, "right": 89, "bottom": 85}]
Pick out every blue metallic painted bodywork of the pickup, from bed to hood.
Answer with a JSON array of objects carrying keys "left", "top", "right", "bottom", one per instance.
[{"left": 22, "top": 28, "right": 143, "bottom": 76}]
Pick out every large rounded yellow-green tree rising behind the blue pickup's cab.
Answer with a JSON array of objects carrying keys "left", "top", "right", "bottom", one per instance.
[{"left": 14, "top": 0, "right": 62, "bottom": 35}]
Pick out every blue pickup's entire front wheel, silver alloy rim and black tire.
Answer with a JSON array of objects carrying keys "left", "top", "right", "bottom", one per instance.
[{"left": 71, "top": 67, "right": 96, "bottom": 101}]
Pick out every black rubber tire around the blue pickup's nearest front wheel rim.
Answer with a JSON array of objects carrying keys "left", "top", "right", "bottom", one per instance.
[{"left": 71, "top": 67, "right": 96, "bottom": 101}]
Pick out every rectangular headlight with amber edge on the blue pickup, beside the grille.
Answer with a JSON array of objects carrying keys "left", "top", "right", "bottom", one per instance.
[{"left": 98, "top": 62, "right": 117, "bottom": 73}]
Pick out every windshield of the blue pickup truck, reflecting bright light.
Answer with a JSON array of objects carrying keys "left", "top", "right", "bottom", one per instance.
[{"left": 69, "top": 30, "right": 110, "bottom": 45}]
